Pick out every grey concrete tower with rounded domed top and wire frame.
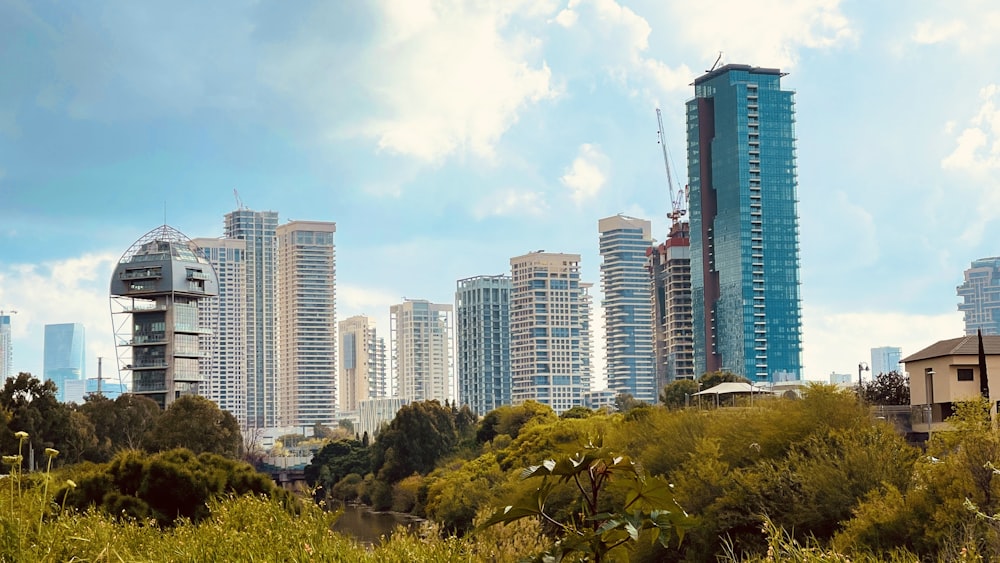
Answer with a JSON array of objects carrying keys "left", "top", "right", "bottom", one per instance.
[{"left": 111, "top": 225, "right": 218, "bottom": 408}]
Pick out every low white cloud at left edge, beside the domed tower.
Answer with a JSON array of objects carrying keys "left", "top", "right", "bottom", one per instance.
[{"left": 0, "top": 253, "right": 119, "bottom": 378}]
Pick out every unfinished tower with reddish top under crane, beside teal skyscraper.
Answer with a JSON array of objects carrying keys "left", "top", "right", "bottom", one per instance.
[{"left": 647, "top": 221, "right": 701, "bottom": 389}]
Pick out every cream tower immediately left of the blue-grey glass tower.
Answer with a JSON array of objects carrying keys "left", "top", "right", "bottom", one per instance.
[{"left": 389, "top": 299, "right": 455, "bottom": 403}]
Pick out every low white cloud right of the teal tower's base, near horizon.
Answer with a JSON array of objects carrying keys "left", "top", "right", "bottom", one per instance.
[{"left": 802, "top": 304, "right": 965, "bottom": 381}]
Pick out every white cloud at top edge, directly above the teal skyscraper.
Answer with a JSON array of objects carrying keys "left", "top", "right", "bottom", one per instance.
[{"left": 672, "top": 0, "right": 857, "bottom": 69}]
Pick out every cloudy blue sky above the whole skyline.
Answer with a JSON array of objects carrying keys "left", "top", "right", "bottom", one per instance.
[{"left": 0, "top": 0, "right": 1000, "bottom": 386}]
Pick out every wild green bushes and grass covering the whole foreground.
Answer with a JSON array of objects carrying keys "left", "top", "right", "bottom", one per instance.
[{"left": 0, "top": 368, "right": 1000, "bottom": 561}]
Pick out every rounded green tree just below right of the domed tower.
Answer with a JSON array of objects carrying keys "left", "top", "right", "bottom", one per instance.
[{"left": 147, "top": 395, "right": 243, "bottom": 458}]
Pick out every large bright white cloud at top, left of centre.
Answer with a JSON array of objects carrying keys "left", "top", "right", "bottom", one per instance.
[{"left": 359, "top": 0, "right": 556, "bottom": 162}]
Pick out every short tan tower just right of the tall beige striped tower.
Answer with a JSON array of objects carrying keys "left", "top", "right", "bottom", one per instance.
[{"left": 338, "top": 315, "right": 388, "bottom": 412}]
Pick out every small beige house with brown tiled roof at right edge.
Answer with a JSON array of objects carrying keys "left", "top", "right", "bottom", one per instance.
[{"left": 901, "top": 335, "right": 1000, "bottom": 430}]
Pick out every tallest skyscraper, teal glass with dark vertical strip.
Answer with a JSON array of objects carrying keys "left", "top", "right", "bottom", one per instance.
[{"left": 687, "top": 65, "right": 802, "bottom": 381}]
